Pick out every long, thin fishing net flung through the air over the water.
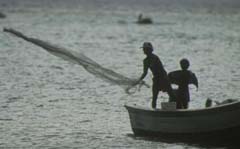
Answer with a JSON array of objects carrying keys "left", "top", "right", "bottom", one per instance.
[{"left": 4, "top": 29, "right": 149, "bottom": 94}]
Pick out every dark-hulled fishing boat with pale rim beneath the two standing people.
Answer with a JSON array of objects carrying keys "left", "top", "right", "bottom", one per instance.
[{"left": 125, "top": 101, "right": 240, "bottom": 144}]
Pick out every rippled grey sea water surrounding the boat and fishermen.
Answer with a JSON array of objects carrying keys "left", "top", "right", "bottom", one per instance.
[{"left": 0, "top": 0, "right": 240, "bottom": 149}]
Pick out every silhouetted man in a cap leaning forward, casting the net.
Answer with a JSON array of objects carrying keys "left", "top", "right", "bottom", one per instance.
[{"left": 136, "top": 42, "right": 175, "bottom": 108}]
